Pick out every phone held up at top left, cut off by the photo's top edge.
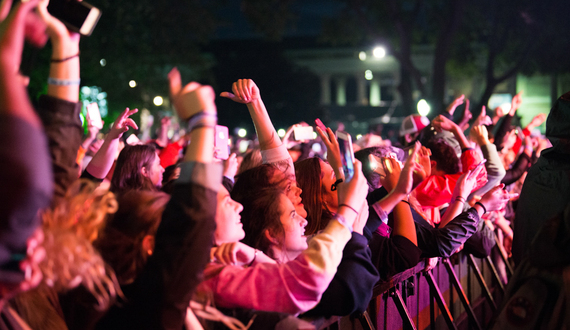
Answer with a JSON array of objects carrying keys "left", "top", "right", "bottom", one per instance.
[{"left": 48, "top": 0, "right": 101, "bottom": 36}]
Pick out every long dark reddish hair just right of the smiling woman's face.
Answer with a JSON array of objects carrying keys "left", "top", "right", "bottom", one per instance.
[{"left": 295, "top": 157, "right": 333, "bottom": 235}]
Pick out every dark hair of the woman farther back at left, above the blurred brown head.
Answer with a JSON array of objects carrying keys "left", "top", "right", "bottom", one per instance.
[{"left": 110, "top": 144, "right": 158, "bottom": 194}]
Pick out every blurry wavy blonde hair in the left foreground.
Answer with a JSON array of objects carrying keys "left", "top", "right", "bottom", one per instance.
[{"left": 40, "top": 180, "right": 122, "bottom": 309}]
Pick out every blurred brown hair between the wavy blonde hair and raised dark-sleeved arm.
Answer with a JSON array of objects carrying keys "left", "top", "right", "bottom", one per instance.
[{"left": 94, "top": 190, "right": 170, "bottom": 284}]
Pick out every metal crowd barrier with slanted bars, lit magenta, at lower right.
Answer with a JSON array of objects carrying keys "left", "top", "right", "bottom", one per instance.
[{"left": 315, "top": 240, "right": 513, "bottom": 330}]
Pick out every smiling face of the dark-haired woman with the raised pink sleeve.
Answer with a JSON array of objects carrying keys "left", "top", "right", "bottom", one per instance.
[{"left": 279, "top": 194, "right": 308, "bottom": 258}]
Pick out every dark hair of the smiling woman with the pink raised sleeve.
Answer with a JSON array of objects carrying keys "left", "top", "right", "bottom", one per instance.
[{"left": 236, "top": 188, "right": 286, "bottom": 257}]
